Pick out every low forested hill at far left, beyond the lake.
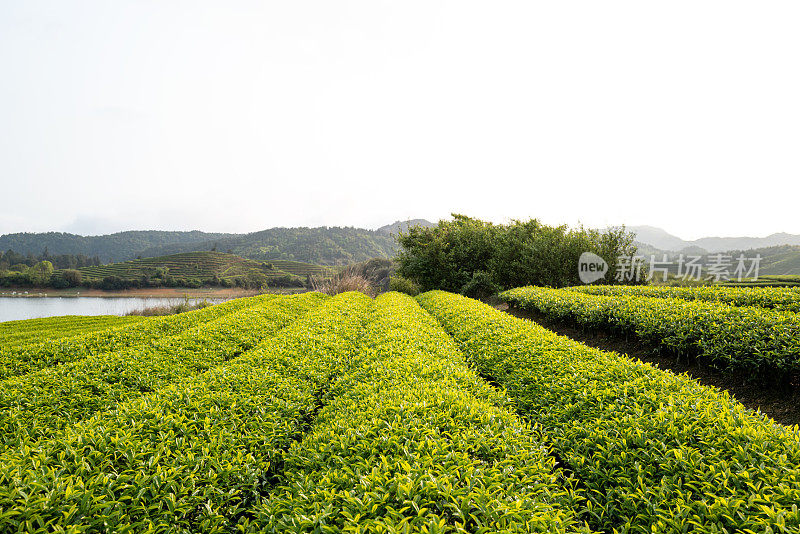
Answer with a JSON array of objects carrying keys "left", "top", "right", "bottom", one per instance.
[{"left": 0, "top": 230, "right": 236, "bottom": 263}]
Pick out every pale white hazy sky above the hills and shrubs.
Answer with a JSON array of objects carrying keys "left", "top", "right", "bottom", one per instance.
[{"left": 0, "top": 0, "right": 800, "bottom": 239}]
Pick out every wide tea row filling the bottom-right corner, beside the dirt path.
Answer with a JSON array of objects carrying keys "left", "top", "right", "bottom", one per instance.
[{"left": 417, "top": 291, "right": 800, "bottom": 533}]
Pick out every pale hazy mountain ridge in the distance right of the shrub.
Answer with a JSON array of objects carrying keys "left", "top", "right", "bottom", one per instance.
[{"left": 627, "top": 226, "right": 800, "bottom": 253}]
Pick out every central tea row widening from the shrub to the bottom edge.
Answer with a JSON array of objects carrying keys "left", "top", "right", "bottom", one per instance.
[{"left": 251, "top": 293, "right": 585, "bottom": 533}]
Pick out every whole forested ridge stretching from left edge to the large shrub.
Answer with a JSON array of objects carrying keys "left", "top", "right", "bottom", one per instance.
[{"left": 0, "top": 227, "right": 406, "bottom": 265}]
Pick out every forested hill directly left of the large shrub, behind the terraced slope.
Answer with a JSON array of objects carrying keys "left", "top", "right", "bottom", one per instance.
[{"left": 141, "top": 226, "right": 398, "bottom": 265}]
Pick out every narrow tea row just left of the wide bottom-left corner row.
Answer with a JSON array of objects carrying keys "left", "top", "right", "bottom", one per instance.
[{"left": 0, "top": 293, "right": 328, "bottom": 452}]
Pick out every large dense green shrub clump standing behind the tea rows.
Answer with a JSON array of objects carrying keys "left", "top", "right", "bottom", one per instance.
[{"left": 397, "top": 214, "right": 636, "bottom": 296}]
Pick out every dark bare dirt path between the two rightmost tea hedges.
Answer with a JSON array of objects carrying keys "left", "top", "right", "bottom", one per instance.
[{"left": 496, "top": 304, "right": 800, "bottom": 425}]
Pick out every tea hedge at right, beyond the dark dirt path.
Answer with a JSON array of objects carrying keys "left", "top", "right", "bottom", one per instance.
[{"left": 500, "top": 287, "right": 800, "bottom": 382}]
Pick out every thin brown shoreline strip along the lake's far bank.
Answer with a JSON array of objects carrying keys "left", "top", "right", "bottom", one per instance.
[{"left": 0, "top": 287, "right": 306, "bottom": 300}]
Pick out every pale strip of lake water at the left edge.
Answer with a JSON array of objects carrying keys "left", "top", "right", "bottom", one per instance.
[{"left": 0, "top": 297, "right": 223, "bottom": 322}]
